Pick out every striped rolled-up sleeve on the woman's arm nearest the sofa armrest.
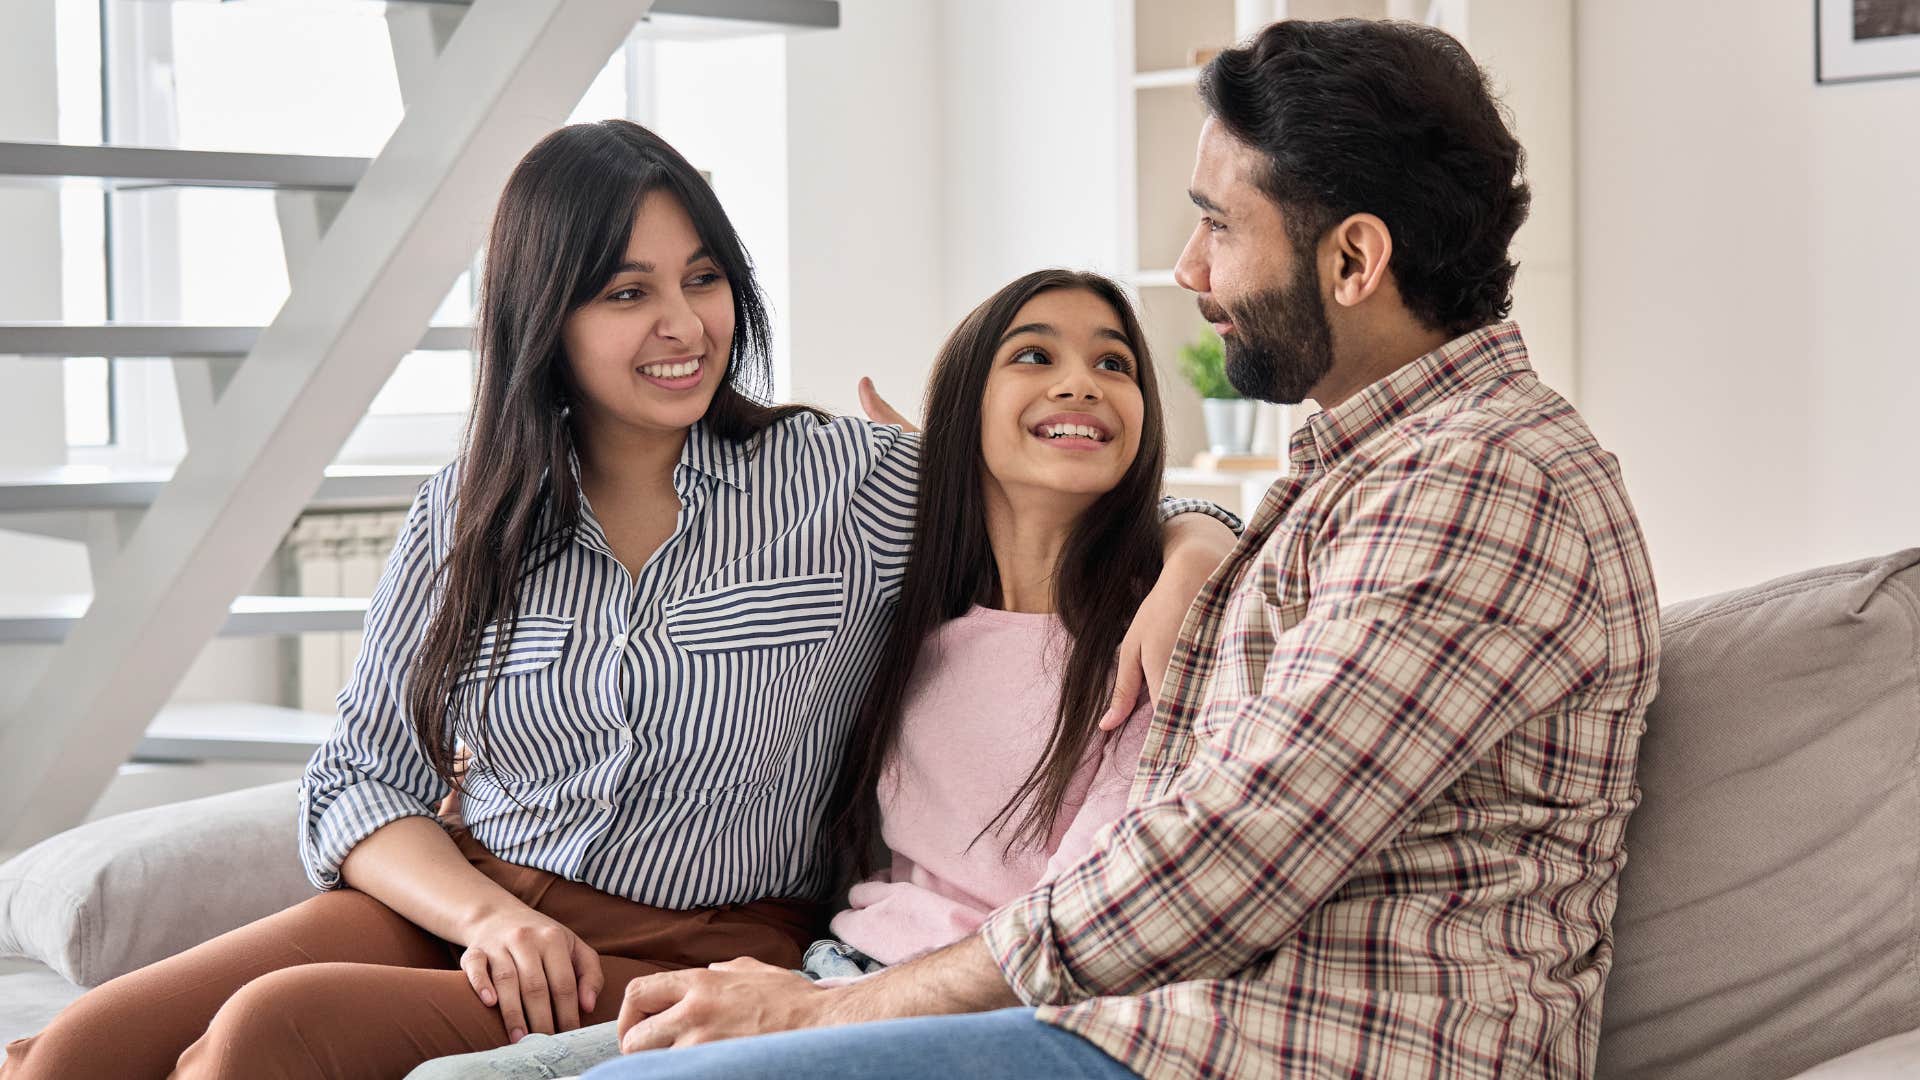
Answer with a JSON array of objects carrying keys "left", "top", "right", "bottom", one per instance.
[{"left": 300, "top": 473, "right": 451, "bottom": 890}]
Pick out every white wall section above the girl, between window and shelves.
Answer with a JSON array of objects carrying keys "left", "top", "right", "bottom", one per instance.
[{"left": 787, "top": 0, "right": 1121, "bottom": 415}]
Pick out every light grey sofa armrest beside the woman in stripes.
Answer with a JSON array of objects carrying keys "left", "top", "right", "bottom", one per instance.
[{"left": 0, "top": 782, "right": 313, "bottom": 986}]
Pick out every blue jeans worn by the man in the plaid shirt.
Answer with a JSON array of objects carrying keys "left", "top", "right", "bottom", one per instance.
[{"left": 586, "top": 1009, "right": 1137, "bottom": 1080}]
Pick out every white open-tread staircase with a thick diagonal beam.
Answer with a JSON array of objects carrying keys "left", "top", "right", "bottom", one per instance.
[{"left": 0, "top": 0, "right": 839, "bottom": 849}]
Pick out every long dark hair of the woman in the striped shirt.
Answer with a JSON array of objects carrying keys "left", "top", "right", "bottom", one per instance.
[{"left": 405, "top": 119, "right": 801, "bottom": 784}]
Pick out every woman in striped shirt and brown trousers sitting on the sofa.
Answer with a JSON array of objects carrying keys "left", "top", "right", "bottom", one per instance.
[{"left": 0, "top": 121, "right": 1217, "bottom": 1078}]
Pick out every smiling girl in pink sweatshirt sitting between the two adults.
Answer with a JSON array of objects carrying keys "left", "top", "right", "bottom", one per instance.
[{"left": 420, "top": 269, "right": 1165, "bottom": 1080}]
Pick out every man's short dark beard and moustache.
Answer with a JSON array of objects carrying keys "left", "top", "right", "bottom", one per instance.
[{"left": 1200, "top": 259, "right": 1332, "bottom": 405}]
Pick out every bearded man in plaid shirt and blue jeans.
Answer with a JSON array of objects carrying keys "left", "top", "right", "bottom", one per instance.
[{"left": 576, "top": 21, "right": 1659, "bottom": 1080}]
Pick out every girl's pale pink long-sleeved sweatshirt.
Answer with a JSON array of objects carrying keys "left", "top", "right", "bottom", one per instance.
[{"left": 833, "top": 607, "right": 1152, "bottom": 965}]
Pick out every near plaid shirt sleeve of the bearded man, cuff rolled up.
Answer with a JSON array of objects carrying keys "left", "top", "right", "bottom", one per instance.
[{"left": 981, "top": 442, "right": 1607, "bottom": 1005}]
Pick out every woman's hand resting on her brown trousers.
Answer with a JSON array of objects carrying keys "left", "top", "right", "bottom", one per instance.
[{"left": 461, "top": 905, "right": 607, "bottom": 1042}]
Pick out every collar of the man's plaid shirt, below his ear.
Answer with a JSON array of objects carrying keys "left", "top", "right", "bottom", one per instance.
[{"left": 1288, "top": 323, "right": 1532, "bottom": 473}]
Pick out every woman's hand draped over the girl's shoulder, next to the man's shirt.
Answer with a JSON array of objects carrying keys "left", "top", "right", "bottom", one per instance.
[{"left": 1100, "top": 513, "right": 1235, "bottom": 730}]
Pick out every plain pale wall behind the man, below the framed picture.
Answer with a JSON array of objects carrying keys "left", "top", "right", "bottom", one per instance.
[{"left": 1576, "top": 0, "right": 1920, "bottom": 601}]
